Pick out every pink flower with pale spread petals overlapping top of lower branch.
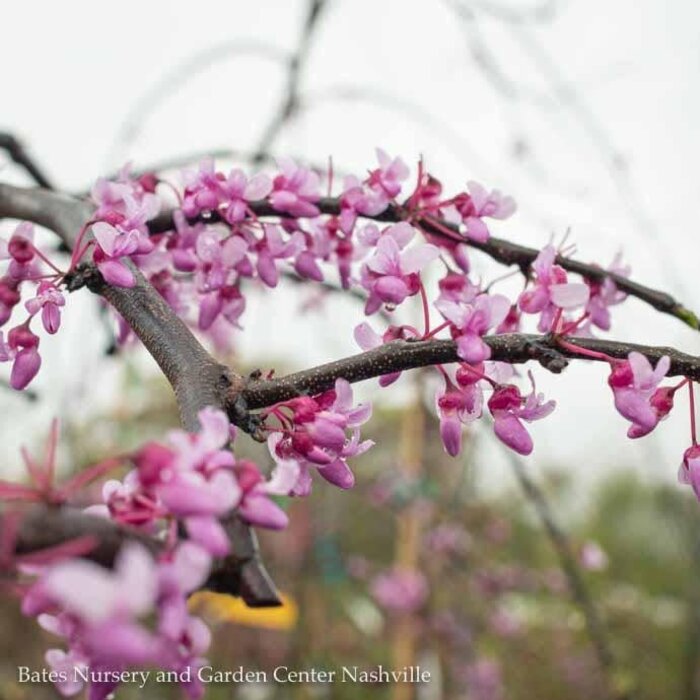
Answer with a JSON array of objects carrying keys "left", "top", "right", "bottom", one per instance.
[{"left": 435, "top": 294, "right": 510, "bottom": 364}]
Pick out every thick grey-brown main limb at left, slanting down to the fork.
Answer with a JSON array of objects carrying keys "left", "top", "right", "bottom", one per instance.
[{"left": 0, "top": 183, "right": 279, "bottom": 606}]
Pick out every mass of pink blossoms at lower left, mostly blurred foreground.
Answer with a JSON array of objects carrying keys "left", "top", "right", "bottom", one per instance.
[{"left": 0, "top": 396, "right": 371, "bottom": 699}]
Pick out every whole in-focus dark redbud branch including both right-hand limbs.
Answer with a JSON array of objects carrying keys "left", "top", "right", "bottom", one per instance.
[{"left": 0, "top": 176, "right": 700, "bottom": 604}]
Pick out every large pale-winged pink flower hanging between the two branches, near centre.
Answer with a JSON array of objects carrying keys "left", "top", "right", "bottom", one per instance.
[{"left": 361, "top": 222, "right": 440, "bottom": 315}]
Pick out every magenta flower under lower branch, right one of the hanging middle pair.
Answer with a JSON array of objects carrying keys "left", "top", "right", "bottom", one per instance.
[{"left": 488, "top": 372, "right": 556, "bottom": 455}]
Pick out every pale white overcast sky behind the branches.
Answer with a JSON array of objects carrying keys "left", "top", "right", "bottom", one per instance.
[{"left": 0, "top": 0, "right": 700, "bottom": 494}]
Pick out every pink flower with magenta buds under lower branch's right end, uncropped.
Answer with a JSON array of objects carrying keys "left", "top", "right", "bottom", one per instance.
[{"left": 608, "top": 351, "right": 673, "bottom": 437}]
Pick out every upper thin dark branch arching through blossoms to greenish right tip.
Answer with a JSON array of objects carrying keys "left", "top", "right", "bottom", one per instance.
[{"left": 149, "top": 197, "right": 700, "bottom": 330}]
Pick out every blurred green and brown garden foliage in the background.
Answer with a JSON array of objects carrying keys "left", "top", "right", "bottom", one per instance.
[{"left": 0, "top": 359, "right": 700, "bottom": 700}]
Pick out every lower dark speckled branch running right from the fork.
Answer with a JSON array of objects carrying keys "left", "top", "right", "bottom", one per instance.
[{"left": 236, "top": 333, "right": 700, "bottom": 410}]
